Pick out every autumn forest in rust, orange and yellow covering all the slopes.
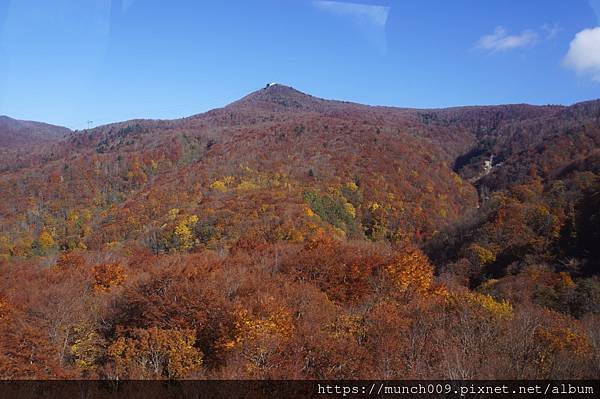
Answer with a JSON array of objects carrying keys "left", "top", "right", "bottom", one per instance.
[{"left": 0, "top": 85, "right": 600, "bottom": 379}]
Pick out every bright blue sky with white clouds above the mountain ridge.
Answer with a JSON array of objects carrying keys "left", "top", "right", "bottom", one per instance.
[{"left": 0, "top": 0, "right": 600, "bottom": 128}]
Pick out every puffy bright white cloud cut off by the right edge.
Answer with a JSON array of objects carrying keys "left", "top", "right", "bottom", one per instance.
[{"left": 563, "top": 26, "right": 600, "bottom": 82}]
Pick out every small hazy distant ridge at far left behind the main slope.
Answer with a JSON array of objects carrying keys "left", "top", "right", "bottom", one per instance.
[{"left": 0, "top": 116, "right": 70, "bottom": 149}]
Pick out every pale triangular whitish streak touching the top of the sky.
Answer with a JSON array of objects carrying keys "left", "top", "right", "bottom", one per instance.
[{"left": 312, "top": 0, "right": 390, "bottom": 53}]
